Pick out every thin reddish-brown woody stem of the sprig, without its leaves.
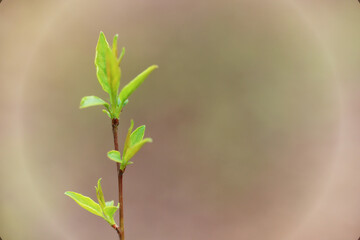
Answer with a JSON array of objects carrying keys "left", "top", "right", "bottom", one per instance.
[{"left": 112, "top": 118, "right": 125, "bottom": 240}]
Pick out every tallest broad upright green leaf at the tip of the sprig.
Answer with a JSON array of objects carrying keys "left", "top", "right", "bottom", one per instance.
[{"left": 95, "top": 32, "right": 111, "bottom": 94}]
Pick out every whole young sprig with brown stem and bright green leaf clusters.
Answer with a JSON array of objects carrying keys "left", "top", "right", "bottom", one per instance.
[{"left": 65, "top": 32, "right": 158, "bottom": 240}]
